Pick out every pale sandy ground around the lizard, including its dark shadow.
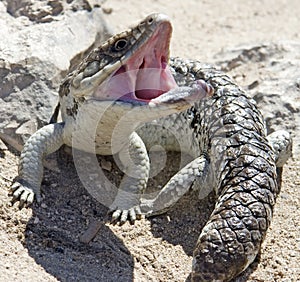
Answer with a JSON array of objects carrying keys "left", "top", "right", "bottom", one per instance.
[{"left": 0, "top": 0, "right": 300, "bottom": 282}]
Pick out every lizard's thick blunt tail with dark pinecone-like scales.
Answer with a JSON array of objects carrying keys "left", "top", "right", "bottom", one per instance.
[{"left": 192, "top": 133, "right": 278, "bottom": 281}]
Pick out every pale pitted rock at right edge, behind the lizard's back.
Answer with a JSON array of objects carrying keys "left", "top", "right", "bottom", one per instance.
[{"left": 215, "top": 42, "right": 300, "bottom": 154}]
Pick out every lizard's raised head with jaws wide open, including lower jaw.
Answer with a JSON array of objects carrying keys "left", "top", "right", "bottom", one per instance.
[{"left": 59, "top": 14, "right": 212, "bottom": 124}]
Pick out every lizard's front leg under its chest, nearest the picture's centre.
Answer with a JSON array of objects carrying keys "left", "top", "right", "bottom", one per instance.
[{"left": 110, "top": 132, "right": 150, "bottom": 224}]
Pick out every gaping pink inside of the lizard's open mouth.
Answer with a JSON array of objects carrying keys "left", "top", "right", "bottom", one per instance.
[{"left": 97, "top": 22, "right": 177, "bottom": 103}]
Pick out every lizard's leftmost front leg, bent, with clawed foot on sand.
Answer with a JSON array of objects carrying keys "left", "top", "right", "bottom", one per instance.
[{"left": 11, "top": 123, "right": 64, "bottom": 208}]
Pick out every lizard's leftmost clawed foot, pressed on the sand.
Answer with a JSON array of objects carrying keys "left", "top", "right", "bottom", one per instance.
[{"left": 11, "top": 181, "right": 41, "bottom": 209}]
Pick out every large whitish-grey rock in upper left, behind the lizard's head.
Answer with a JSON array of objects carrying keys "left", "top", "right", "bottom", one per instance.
[{"left": 0, "top": 0, "right": 111, "bottom": 150}]
